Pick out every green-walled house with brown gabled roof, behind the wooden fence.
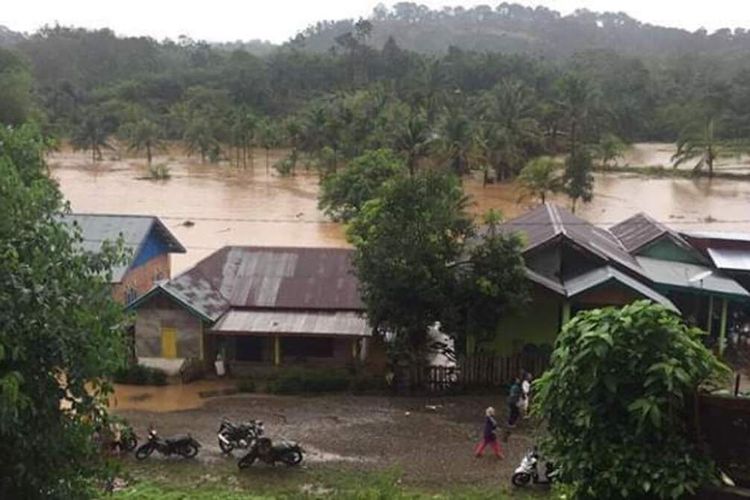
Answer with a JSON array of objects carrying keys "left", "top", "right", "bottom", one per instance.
[{"left": 482, "top": 203, "right": 677, "bottom": 354}]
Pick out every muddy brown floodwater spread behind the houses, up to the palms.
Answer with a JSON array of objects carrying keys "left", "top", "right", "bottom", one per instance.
[{"left": 49, "top": 144, "right": 750, "bottom": 274}]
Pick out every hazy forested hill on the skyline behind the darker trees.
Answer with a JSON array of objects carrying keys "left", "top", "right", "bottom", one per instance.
[{"left": 296, "top": 2, "right": 750, "bottom": 56}]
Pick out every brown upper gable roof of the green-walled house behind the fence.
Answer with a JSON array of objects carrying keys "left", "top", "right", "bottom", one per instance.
[{"left": 501, "top": 203, "right": 643, "bottom": 275}]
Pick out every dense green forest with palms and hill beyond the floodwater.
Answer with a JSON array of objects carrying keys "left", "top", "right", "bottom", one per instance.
[{"left": 0, "top": 3, "right": 750, "bottom": 187}]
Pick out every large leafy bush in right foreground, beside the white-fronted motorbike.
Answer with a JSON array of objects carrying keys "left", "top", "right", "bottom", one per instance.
[{"left": 536, "top": 301, "right": 725, "bottom": 499}]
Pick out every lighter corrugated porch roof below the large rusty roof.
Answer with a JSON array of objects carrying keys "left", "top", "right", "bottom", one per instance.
[{"left": 211, "top": 310, "right": 372, "bottom": 337}]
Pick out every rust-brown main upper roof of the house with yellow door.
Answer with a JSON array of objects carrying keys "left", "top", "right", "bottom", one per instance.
[{"left": 130, "top": 246, "right": 364, "bottom": 321}]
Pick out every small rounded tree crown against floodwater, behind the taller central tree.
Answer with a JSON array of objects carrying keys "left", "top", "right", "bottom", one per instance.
[{"left": 318, "top": 149, "right": 406, "bottom": 221}]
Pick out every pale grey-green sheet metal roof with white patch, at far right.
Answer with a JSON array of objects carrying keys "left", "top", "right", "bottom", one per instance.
[{"left": 637, "top": 257, "right": 750, "bottom": 299}]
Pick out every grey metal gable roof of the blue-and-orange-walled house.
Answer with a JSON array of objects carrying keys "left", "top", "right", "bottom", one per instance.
[{"left": 60, "top": 214, "right": 185, "bottom": 283}]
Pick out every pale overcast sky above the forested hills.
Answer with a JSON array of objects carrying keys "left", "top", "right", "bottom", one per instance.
[{"left": 0, "top": 0, "right": 750, "bottom": 43}]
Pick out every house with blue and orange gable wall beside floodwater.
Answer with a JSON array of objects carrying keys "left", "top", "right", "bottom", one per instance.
[{"left": 61, "top": 213, "right": 185, "bottom": 304}]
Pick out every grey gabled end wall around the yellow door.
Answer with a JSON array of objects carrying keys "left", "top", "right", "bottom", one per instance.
[{"left": 135, "top": 296, "right": 203, "bottom": 358}]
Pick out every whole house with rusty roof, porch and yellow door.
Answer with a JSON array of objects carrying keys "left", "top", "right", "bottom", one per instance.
[{"left": 130, "top": 246, "right": 372, "bottom": 373}]
